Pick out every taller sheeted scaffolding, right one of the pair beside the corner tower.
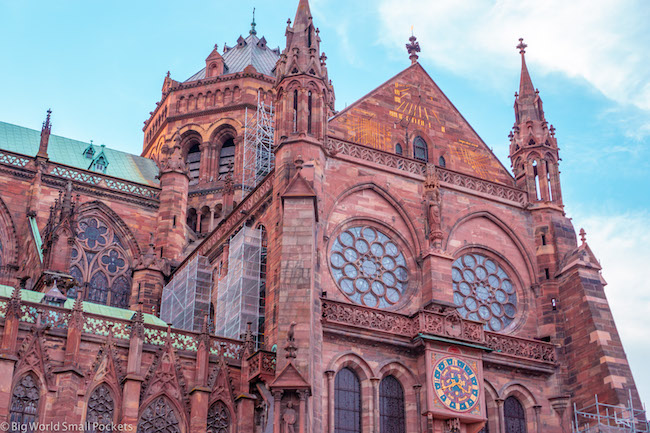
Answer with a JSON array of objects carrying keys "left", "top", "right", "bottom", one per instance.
[{"left": 215, "top": 226, "right": 262, "bottom": 339}]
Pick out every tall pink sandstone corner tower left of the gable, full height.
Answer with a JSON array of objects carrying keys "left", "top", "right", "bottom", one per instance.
[{"left": 267, "top": 0, "right": 334, "bottom": 431}]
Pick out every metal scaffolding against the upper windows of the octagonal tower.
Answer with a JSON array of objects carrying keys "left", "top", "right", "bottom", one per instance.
[{"left": 242, "top": 90, "right": 275, "bottom": 199}]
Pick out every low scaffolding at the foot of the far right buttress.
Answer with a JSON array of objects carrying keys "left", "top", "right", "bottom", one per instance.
[{"left": 571, "top": 391, "right": 650, "bottom": 433}]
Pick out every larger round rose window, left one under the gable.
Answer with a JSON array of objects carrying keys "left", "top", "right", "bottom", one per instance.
[{"left": 330, "top": 226, "right": 409, "bottom": 308}]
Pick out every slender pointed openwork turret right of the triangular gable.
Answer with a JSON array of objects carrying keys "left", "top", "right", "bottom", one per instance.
[{"left": 509, "top": 39, "right": 562, "bottom": 206}]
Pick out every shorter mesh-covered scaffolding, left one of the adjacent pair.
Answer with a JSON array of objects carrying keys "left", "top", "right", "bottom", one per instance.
[{"left": 160, "top": 256, "right": 212, "bottom": 332}]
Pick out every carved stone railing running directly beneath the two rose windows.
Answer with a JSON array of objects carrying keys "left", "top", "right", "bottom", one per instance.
[{"left": 322, "top": 299, "right": 557, "bottom": 364}]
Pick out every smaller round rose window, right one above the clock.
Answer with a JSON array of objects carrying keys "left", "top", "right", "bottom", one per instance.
[{"left": 451, "top": 253, "right": 517, "bottom": 331}]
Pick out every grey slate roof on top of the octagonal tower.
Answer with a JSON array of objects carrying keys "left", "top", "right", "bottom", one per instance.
[{"left": 185, "top": 34, "right": 280, "bottom": 83}]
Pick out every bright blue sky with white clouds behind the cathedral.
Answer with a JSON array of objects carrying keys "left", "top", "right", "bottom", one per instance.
[{"left": 0, "top": 0, "right": 650, "bottom": 403}]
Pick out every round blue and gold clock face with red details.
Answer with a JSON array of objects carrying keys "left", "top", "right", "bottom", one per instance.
[{"left": 433, "top": 356, "right": 480, "bottom": 412}]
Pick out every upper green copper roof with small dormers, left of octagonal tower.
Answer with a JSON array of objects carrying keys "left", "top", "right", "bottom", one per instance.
[{"left": 0, "top": 122, "right": 158, "bottom": 186}]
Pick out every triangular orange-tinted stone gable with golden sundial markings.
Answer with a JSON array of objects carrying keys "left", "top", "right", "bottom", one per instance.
[{"left": 329, "top": 63, "right": 514, "bottom": 185}]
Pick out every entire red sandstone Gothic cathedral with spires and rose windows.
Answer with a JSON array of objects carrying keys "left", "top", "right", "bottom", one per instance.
[{"left": 0, "top": 0, "right": 648, "bottom": 433}]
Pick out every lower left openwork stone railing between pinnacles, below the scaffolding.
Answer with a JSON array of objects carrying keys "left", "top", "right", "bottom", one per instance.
[{"left": 0, "top": 298, "right": 243, "bottom": 359}]
